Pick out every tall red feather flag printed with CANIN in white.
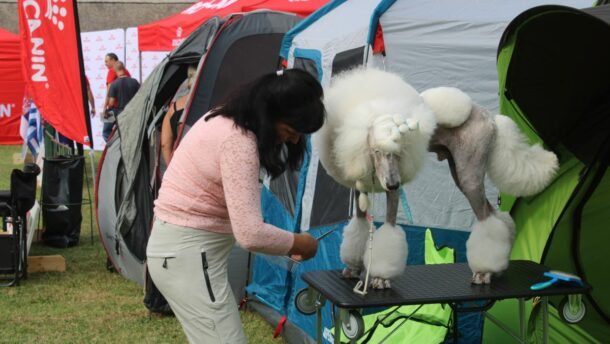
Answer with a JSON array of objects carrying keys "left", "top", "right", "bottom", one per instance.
[{"left": 18, "top": 0, "right": 89, "bottom": 144}]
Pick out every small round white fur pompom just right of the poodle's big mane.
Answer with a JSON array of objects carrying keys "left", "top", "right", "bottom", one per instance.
[{"left": 421, "top": 87, "right": 472, "bottom": 128}]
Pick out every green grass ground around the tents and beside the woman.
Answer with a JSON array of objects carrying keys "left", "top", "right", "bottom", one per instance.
[{"left": 0, "top": 146, "right": 285, "bottom": 344}]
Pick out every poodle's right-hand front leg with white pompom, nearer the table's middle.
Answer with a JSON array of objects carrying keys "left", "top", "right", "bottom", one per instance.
[{"left": 364, "top": 190, "right": 407, "bottom": 289}]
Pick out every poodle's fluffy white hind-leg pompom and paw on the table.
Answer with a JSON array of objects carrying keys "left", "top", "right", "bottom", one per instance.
[{"left": 466, "top": 213, "right": 515, "bottom": 284}]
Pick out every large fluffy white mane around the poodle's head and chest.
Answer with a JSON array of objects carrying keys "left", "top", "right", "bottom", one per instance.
[{"left": 313, "top": 68, "right": 436, "bottom": 192}]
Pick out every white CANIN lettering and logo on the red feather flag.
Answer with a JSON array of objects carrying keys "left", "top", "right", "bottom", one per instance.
[{"left": 23, "top": 0, "right": 68, "bottom": 82}]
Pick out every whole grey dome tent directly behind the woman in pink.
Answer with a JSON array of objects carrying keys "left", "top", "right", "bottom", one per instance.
[{"left": 96, "top": 11, "right": 300, "bottom": 298}]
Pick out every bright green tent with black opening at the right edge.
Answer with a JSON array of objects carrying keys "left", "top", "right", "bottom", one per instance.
[{"left": 483, "top": 5, "right": 610, "bottom": 343}]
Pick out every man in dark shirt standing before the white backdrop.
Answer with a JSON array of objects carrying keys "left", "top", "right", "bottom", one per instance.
[{"left": 102, "top": 61, "right": 140, "bottom": 142}]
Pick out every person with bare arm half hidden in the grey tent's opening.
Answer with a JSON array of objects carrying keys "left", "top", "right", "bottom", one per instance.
[{"left": 161, "top": 65, "right": 197, "bottom": 165}]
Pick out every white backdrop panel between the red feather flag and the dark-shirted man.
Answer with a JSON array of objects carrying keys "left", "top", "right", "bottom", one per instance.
[{"left": 81, "top": 29, "right": 124, "bottom": 150}]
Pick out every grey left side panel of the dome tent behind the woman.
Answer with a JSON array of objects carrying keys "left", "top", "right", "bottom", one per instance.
[{"left": 96, "top": 17, "right": 221, "bottom": 284}]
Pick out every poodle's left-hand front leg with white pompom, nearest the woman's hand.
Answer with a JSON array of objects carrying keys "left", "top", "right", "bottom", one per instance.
[{"left": 339, "top": 191, "right": 369, "bottom": 278}]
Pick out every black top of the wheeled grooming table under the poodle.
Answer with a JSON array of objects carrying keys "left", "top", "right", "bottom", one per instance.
[{"left": 301, "top": 260, "right": 591, "bottom": 309}]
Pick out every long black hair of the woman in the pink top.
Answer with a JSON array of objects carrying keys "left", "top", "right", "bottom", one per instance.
[{"left": 205, "top": 69, "right": 325, "bottom": 178}]
